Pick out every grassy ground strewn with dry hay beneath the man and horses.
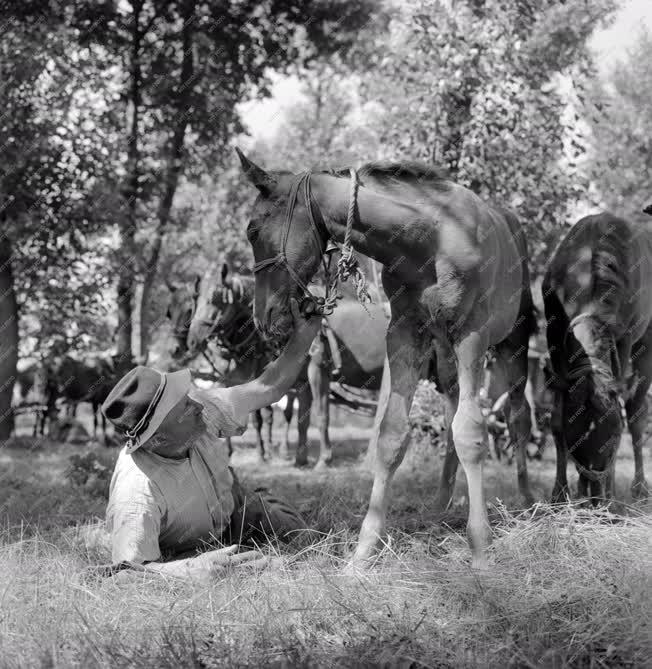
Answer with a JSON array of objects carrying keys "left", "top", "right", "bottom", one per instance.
[{"left": 0, "top": 404, "right": 652, "bottom": 667}]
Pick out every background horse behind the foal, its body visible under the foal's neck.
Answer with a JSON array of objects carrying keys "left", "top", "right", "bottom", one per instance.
[{"left": 188, "top": 265, "right": 387, "bottom": 468}]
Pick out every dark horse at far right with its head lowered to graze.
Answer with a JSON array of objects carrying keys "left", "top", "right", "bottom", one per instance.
[{"left": 542, "top": 212, "right": 652, "bottom": 503}]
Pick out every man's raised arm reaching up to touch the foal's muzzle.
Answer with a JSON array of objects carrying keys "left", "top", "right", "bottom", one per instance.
[{"left": 223, "top": 300, "right": 321, "bottom": 423}]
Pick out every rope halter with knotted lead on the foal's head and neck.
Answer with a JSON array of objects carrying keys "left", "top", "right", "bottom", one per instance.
[{"left": 254, "top": 168, "right": 371, "bottom": 316}]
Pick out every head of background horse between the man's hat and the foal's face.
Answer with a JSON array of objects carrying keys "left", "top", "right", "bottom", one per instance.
[{"left": 188, "top": 263, "right": 253, "bottom": 352}]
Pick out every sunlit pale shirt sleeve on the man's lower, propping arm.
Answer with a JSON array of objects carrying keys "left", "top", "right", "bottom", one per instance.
[{"left": 106, "top": 464, "right": 163, "bottom": 564}]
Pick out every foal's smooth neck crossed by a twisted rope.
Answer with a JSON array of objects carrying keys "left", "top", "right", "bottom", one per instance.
[{"left": 313, "top": 174, "right": 424, "bottom": 266}]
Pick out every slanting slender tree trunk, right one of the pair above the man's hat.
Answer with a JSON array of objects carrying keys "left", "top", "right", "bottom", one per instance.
[{"left": 139, "top": 0, "right": 195, "bottom": 359}]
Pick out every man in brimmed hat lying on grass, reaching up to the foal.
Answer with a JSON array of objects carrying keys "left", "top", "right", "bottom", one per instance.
[{"left": 102, "top": 301, "right": 320, "bottom": 578}]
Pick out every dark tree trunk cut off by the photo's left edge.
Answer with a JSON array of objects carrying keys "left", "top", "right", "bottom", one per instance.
[{"left": 0, "top": 235, "right": 18, "bottom": 441}]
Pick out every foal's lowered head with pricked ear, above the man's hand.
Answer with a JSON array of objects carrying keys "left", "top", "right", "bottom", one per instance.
[{"left": 237, "top": 149, "right": 328, "bottom": 342}]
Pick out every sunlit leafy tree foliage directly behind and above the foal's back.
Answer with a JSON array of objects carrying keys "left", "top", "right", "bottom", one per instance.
[{"left": 356, "top": 0, "right": 614, "bottom": 273}]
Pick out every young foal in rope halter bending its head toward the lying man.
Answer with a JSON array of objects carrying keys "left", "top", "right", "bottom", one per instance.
[{"left": 237, "top": 149, "right": 536, "bottom": 568}]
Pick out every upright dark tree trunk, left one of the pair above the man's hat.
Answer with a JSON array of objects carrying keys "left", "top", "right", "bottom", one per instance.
[{"left": 116, "top": 0, "right": 143, "bottom": 357}]
